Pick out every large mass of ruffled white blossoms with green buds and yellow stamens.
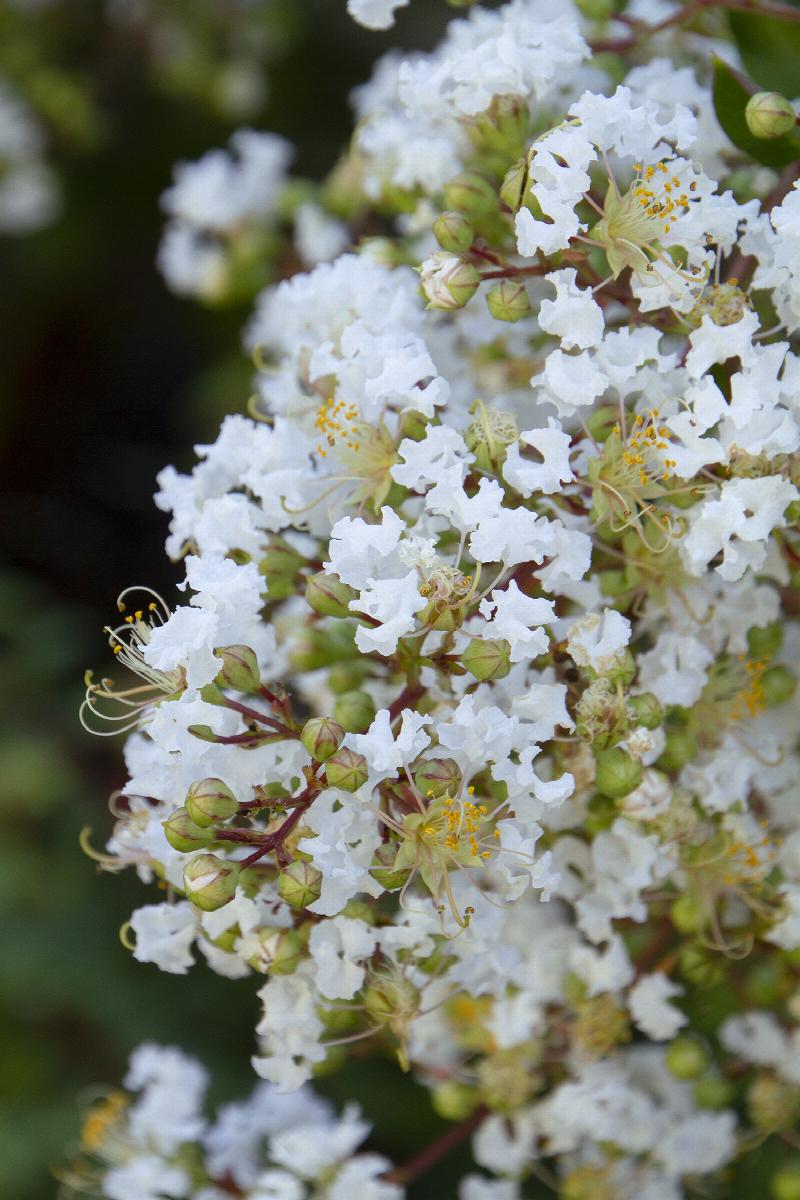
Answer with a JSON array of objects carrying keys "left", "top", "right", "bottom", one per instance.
[{"left": 70, "top": 0, "right": 800, "bottom": 1200}]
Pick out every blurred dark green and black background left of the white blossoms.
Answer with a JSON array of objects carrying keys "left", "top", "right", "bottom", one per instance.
[{"left": 0, "top": 0, "right": 470, "bottom": 1200}]
